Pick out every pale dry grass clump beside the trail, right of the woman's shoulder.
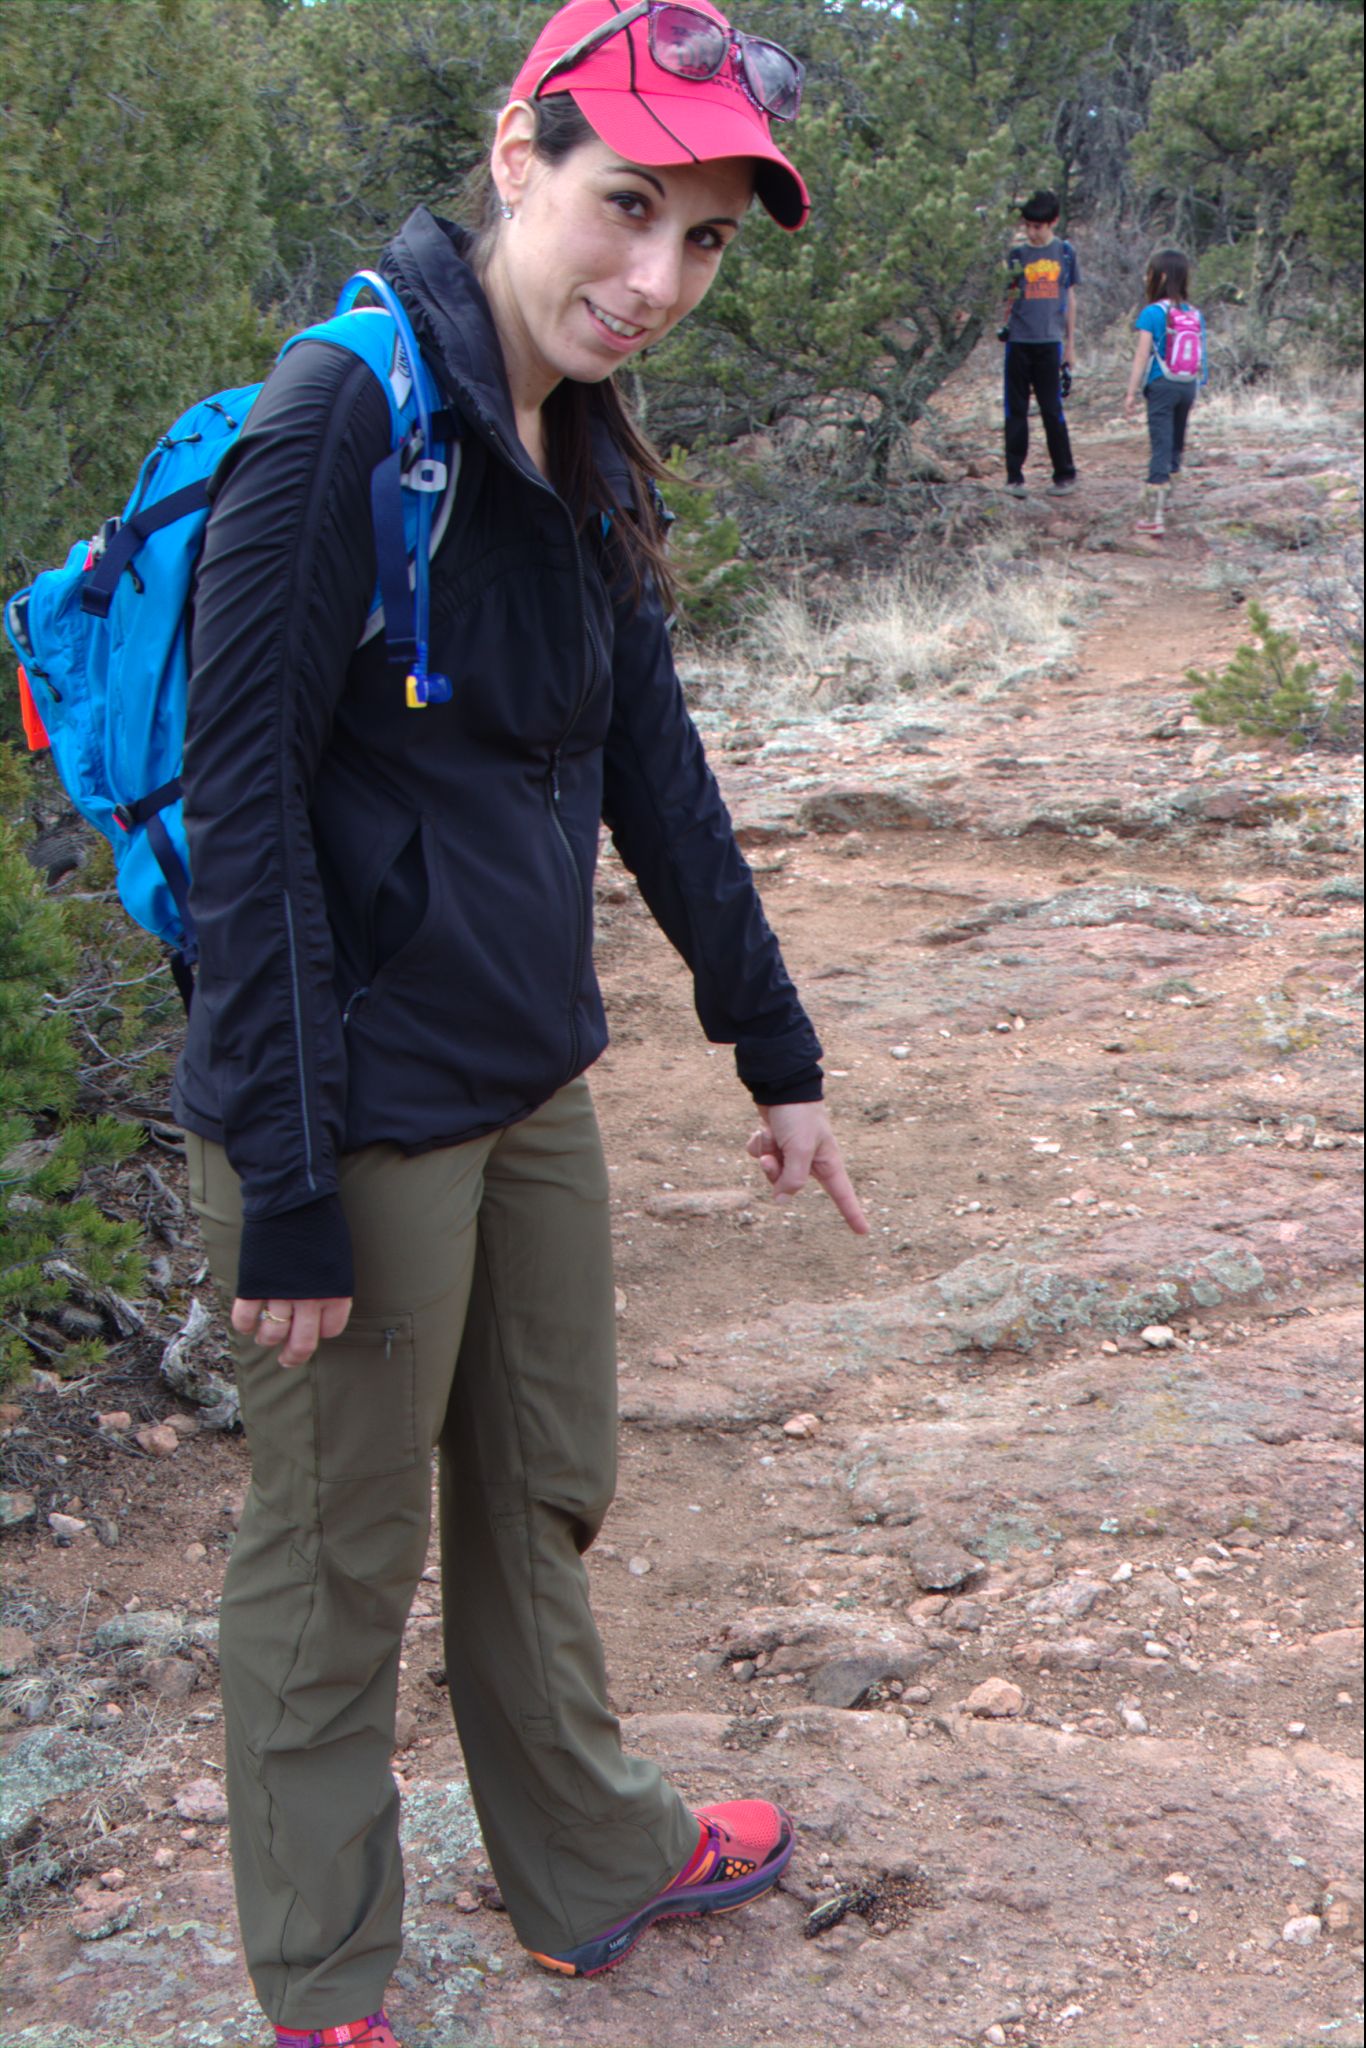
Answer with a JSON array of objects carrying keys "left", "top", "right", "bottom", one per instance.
[{"left": 731, "top": 551, "right": 1083, "bottom": 715}]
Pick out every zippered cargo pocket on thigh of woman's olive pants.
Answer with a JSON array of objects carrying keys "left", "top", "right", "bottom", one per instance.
[{"left": 307, "top": 1315, "right": 428, "bottom": 1481}]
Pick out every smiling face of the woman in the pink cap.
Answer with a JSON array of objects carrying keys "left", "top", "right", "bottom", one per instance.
[{"left": 485, "top": 121, "right": 754, "bottom": 403}]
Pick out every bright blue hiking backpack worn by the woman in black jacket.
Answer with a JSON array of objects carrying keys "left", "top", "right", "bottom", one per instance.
[{"left": 4, "top": 270, "right": 461, "bottom": 1004}]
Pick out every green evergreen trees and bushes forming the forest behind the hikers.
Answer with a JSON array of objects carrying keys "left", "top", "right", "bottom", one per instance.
[{"left": 0, "top": 0, "right": 1362, "bottom": 1382}]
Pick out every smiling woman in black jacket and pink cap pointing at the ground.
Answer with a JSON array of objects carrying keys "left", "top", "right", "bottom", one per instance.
[{"left": 176, "top": 0, "right": 866, "bottom": 2048}]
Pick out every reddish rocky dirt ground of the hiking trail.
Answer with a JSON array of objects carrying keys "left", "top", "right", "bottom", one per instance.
[{"left": 0, "top": 360, "right": 1362, "bottom": 2048}]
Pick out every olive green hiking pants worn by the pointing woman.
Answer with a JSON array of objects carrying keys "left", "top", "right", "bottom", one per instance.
[{"left": 186, "top": 1081, "right": 696, "bottom": 2028}]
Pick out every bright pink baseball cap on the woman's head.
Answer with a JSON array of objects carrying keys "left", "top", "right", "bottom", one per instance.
[{"left": 508, "top": 0, "right": 811, "bottom": 231}]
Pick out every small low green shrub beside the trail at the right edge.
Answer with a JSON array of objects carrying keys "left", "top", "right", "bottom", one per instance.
[{"left": 1186, "top": 602, "right": 1362, "bottom": 748}]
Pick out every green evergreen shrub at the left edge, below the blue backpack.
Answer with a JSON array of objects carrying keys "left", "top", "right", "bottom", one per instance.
[{"left": 0, "top": 760, "right": 141, "bottom": 1386}]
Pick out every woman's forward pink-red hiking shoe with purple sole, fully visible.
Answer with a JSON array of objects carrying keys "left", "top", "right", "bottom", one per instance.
[{"left": 530, "top": 1798, "right": 793, "bottom": 1976}]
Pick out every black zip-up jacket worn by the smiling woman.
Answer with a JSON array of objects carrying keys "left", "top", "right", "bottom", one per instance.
[{"left": 174, "top": 209, "right": 821, "bottom": 1298}]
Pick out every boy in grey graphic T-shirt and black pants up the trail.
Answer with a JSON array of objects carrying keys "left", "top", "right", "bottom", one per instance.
[{"left": 1001, "top": 193, "right": 1081, "bottom": 498}]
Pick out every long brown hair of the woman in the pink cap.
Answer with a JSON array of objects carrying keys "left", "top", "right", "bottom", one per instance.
[{"left": 467, "top": 92, "right": 674, "bottom": 610}]
